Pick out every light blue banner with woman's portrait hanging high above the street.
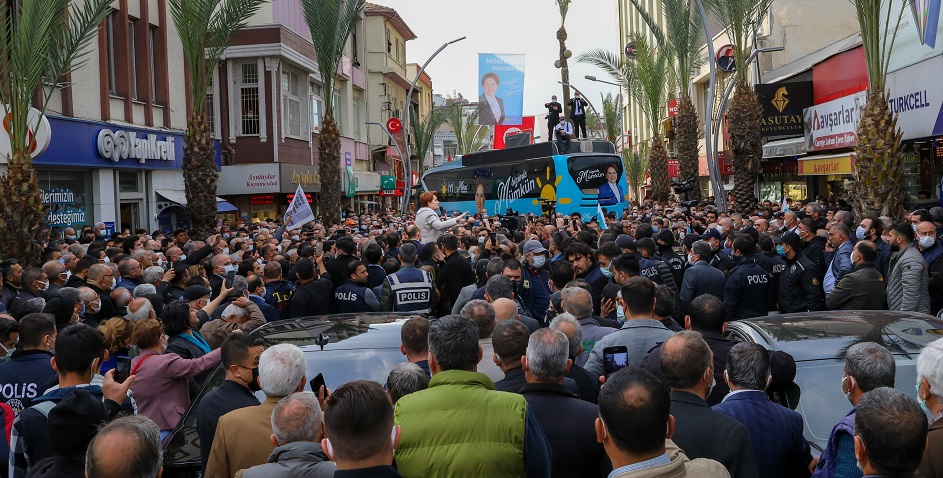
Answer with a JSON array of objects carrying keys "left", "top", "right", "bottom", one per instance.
[{"left": 478, "top": 53, "right": 524, "bottom": 126}]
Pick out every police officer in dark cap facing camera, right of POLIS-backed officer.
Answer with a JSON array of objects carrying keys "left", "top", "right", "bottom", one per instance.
[{"left": 775, "top": 232, "right": 825, "bottom": 314}]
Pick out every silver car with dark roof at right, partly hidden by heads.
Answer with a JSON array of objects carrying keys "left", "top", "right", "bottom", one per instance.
[{"left": 727, "top": 311, "right": 943, "bottom": 450}]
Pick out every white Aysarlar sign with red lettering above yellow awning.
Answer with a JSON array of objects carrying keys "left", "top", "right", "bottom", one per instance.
[{"left": 803, "top": 91, "right": 867, "bottom": 151}]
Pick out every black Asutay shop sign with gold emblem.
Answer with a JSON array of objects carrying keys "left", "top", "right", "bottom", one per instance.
[{"left": 756, "top": 81, "right": 812, "bottom": 138}]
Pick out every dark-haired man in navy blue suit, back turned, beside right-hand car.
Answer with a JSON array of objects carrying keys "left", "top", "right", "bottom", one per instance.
[{"left": 714, "top": 342, "right": 812, "bottom": 478}]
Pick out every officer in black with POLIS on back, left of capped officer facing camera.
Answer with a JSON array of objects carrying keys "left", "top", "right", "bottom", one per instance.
[{"left": 724, "top": 234, "right": 770, "bottom": 321}]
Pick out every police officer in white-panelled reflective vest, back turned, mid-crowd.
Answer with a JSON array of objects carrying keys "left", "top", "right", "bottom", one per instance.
[{"left": 380, "top": 242, "right": 436, "bottom": 313}]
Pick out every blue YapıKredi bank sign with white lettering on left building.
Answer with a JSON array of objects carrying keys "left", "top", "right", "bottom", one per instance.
[{"left": 33, "top": 116, "right": 220, "bottom": 170}]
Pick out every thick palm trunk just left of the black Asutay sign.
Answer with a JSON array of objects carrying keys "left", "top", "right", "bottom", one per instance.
[{"left": 727, "top": 80, "right": 763, "bottom": 215}]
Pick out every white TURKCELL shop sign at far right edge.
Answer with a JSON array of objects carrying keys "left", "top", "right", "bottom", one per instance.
[{"left": 887, "top": 54, "right": 943, "bottom": 140}]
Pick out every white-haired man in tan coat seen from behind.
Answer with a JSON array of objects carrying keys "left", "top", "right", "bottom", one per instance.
[{"left": 204, "top": 344, "right": 307, "bottom": 478}]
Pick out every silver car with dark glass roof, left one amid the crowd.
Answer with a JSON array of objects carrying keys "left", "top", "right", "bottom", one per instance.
[{"left": 163, "top": 313, "right": 424, "bottom": 478}]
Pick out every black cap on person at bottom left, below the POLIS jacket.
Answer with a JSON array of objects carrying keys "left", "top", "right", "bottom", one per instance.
[{"left": 46, "top": 389, "right": 105, "bottom": 456}]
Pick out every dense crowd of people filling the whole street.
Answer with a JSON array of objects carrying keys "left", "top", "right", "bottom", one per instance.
[{"left": 0, "top": 192, "right": 943, "bottom": 478}]
